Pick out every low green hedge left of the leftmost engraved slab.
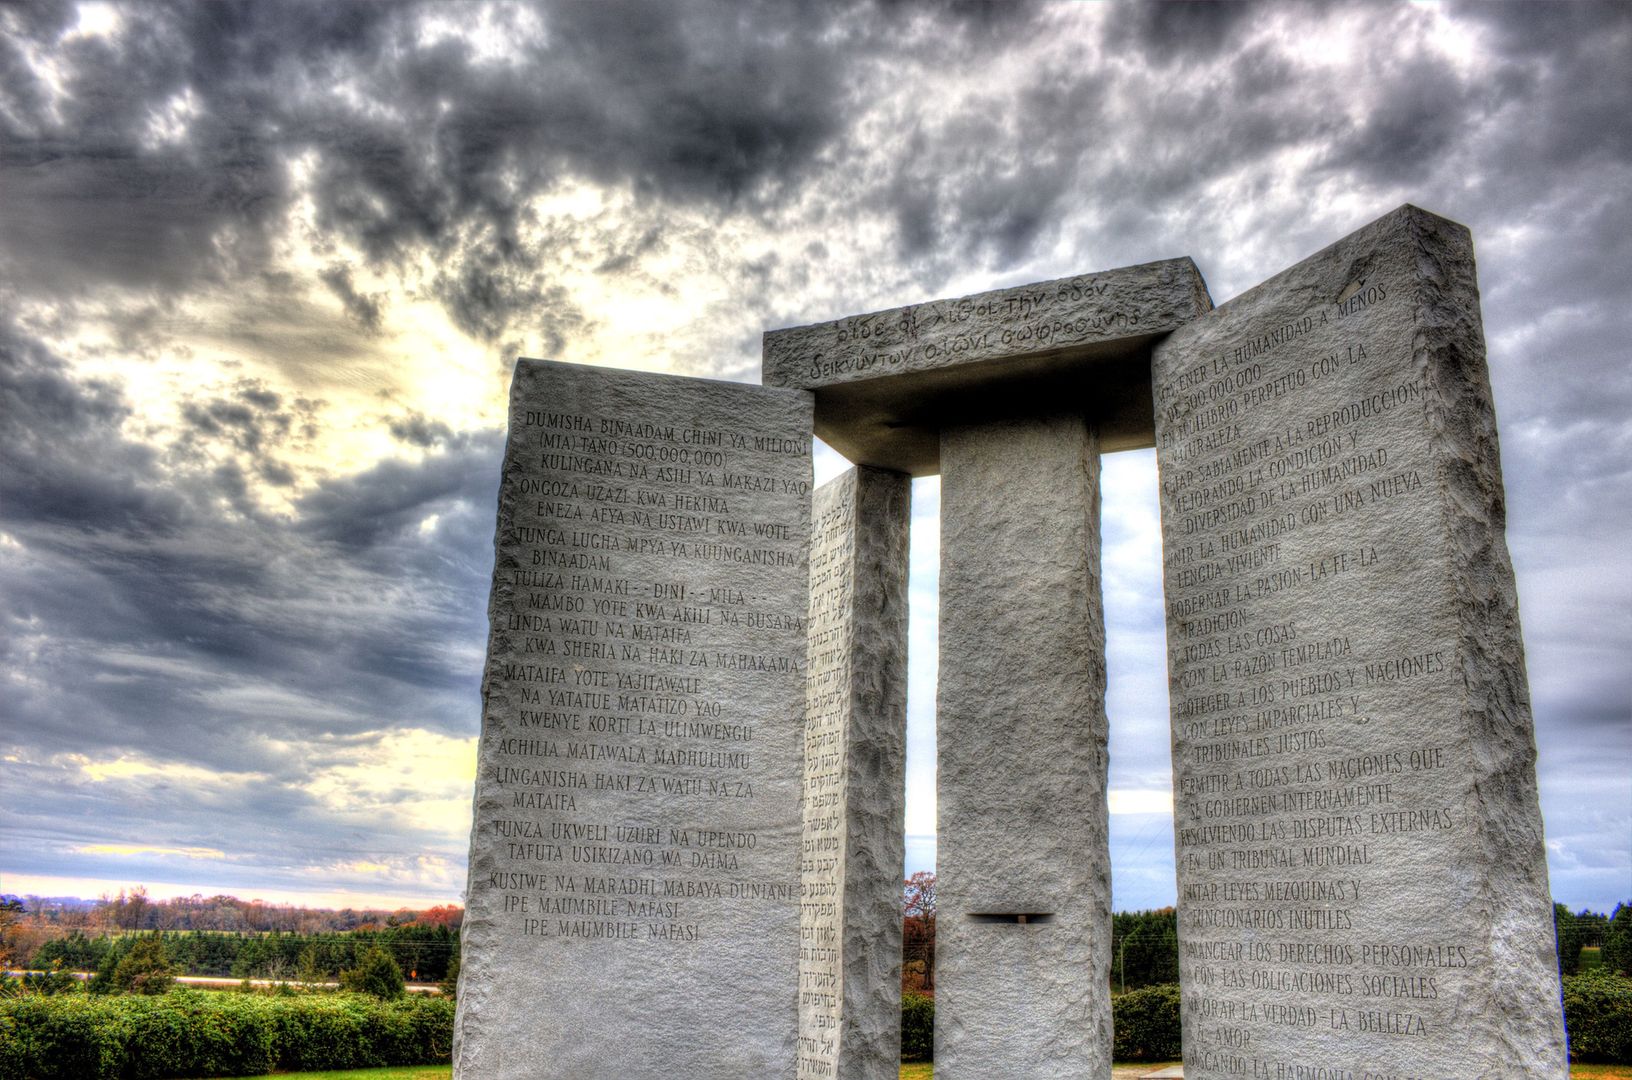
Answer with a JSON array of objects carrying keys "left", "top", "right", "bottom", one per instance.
[{"left": 0, "top": 990, "right": 454, "bottom": 1080}]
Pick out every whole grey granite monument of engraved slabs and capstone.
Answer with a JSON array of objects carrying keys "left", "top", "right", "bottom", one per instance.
[{"left": 454, "top": 206, "right": 1567, "bottom": 1080}]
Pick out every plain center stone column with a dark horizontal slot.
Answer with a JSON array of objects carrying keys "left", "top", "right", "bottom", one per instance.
[{"left": 935, "top": 416, "right": 1111, "bottom": 1080}]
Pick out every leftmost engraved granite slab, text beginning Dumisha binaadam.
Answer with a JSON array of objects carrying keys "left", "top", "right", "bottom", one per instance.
[{"left": 454, "top": 361, "right": 811, "bottom": 1080}]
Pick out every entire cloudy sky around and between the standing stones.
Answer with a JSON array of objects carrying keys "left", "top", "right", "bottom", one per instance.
[{"left": 0, "top": 2, "right": 1632, "bottom": 910}]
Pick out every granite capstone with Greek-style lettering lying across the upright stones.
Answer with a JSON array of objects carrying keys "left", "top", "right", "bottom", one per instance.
[{"left": 762, "top": 258, "right": 1211, "bottom": 476}]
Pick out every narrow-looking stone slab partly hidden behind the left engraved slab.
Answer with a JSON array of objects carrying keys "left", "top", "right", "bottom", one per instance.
[{"left": 798, "top": 467, "right": 911, "bottom": 1080}]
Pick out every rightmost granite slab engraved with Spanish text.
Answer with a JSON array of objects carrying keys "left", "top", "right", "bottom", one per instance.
[{"left": 1154, "top": 206, "right": 1567, "bottom": 1080}]
